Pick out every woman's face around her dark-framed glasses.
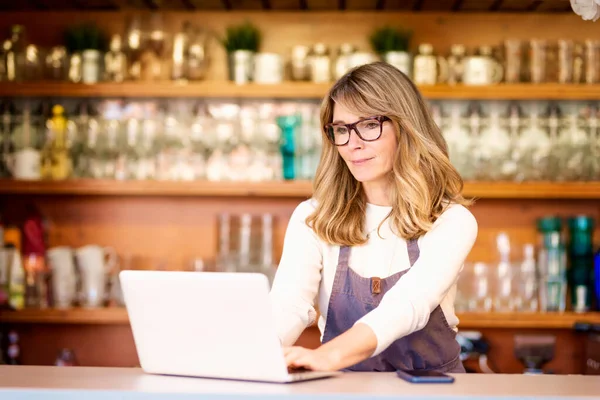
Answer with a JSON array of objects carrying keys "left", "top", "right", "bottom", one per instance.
[{"left": 333, "top": 103, "right": 398, "bottom": 184}]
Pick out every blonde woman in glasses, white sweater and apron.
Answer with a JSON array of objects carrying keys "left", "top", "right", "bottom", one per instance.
[{"left": 271, "top": 63, "right": 477, "bottom": 372}]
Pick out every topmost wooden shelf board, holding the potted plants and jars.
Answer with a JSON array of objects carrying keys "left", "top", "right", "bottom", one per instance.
[{"left": 0, "top": 81, "right": 600, "bottom": 100}]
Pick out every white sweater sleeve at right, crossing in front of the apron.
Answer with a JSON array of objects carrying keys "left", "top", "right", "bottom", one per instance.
[{"left": 356, "top": 205, "right": 477, "bottom": 356}]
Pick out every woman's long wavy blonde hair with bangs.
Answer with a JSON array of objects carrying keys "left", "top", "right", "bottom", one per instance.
[{"left": 306, "top": 62, "right": 471, "bottom": 246}]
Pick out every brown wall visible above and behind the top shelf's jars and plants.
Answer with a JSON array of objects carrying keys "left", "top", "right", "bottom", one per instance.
[{"left": 0, "top": 11, "right": 600, "bottom": 80}]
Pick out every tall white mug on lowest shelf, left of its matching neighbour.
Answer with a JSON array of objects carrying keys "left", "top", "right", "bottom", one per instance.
[{"left": 46, "top": 246, "right": 77, "bottom": 308}]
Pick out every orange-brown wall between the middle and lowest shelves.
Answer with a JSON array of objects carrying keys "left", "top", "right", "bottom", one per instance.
[{"left": 1, "top": 195, "right": 600, "bottom": 269}]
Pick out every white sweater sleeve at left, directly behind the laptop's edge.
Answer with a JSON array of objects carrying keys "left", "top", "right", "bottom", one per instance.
[{"left": 270, "top": 201, "right": 323, "bottom": 346}]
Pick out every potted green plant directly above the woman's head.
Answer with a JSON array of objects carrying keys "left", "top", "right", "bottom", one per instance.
[{"left": 369, "top": 26, "right": 412, "bottom": 77}]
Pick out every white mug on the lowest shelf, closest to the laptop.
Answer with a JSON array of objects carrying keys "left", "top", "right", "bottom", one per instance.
[{"left": 75, "top": 245, "right": 117, "bottom": 308}]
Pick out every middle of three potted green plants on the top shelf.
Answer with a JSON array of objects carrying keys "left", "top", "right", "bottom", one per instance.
[{"left": 221, "top": 21, "right": 261, "bottom": 84}]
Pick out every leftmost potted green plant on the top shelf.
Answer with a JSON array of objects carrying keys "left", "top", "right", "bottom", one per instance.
[{"left": 65, "top": 24, "right": 106, "bottom": 83}]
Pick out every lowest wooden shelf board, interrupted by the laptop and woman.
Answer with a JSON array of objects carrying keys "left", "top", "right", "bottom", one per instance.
[{"left": 0, "top": 307, "right": 600, "bottom": 330}]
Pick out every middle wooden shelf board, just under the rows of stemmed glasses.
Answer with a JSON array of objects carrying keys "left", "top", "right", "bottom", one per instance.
[{"left": 0, "top": 179, "right": 600, "bottom": 199}]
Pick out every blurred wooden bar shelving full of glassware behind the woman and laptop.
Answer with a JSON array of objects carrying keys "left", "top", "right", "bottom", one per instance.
[{"left": 0, "top": 0, "right": 600, "bottom": 374}]
